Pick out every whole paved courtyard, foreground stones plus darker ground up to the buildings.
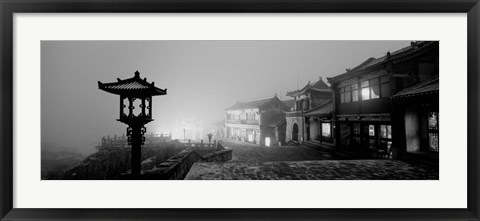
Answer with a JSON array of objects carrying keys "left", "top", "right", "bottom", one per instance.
[{"left": 185, "top": 143, "right": 439, "bottom": 180}]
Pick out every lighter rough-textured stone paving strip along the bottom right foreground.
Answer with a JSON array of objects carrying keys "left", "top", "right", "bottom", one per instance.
[{"left": 185, "top": 160, "right": 438, "bottom": 180}]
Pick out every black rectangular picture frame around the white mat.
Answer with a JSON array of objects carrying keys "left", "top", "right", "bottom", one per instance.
[{"left": 0, "top": 0, "right": 480, "bottom": 220}]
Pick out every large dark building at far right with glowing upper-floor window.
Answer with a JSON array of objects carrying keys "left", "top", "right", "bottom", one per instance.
[{"left": 328, "top": 41, "right": 439, "bottom": 157}]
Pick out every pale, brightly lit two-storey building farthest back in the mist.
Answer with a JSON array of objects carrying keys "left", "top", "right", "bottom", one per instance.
[{"left": 225, "top": 95, "right": 289, "bottom": 146}]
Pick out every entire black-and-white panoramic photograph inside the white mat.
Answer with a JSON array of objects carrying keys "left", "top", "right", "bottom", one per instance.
[{"left": 41, "top": 39, "right": 440, "bottom": 180}]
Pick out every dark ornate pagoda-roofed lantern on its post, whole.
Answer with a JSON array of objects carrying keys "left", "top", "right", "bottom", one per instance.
[{"left": 98, "top": 71, "right": 167, "bottom": 176}]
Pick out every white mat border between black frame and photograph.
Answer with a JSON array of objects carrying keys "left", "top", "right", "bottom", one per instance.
[{"left": 13, "top": 13, "right": 467, "bottom": 208}]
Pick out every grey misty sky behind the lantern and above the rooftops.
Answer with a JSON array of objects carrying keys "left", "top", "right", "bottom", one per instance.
[{"left": 41, "top": 41, "right": 410, "bottom": 153}]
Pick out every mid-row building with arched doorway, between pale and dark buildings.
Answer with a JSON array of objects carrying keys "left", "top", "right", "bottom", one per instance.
[{"left": 286, "top": 78, "right": 334, "bottom": 147}]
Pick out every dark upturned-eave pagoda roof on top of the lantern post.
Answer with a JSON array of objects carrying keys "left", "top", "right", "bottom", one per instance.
[{"left": 98, "top": 71, "right": 167, "bottom": 96}]
